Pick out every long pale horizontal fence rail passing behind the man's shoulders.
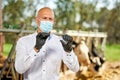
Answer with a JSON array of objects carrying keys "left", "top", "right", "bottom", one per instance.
[{"left": 0, "top": 29, "right": 107, "bottom": 37}]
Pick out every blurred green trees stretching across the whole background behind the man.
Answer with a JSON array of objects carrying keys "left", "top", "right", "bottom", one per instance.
[{"left": 3, "top": 0, "right": 120, "bottom": 42}]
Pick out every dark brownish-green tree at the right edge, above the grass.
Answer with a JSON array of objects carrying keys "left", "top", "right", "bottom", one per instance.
[{"left": 105, "top": 6, "right": 120, "bottom": 43}]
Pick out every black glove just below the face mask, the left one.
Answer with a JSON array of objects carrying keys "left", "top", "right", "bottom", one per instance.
[{"left": 35, "top": 32, "right": 50, "bottom": 51}]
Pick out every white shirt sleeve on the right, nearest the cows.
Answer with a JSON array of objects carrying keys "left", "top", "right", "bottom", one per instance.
[{"left": 63, "top": 50, "right": 79, "bottom": 72}]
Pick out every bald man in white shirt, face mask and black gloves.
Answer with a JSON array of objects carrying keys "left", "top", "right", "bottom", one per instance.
[{"left": 15, "top": 7, "right": 79, "bottom": 80}]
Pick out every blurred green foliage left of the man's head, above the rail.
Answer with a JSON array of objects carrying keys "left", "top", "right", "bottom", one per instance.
[{"left": 3, "top": 0, "right": 35, "bottom": 29}]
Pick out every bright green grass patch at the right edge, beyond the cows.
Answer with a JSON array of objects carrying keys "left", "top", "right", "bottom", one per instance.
[{"left": 105, "top": 44, "right": 120, "bottom": 61}]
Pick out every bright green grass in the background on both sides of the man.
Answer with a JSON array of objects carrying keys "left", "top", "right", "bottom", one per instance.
[{"left": 3, "top": 44, "right": 120, "bottom": 61}]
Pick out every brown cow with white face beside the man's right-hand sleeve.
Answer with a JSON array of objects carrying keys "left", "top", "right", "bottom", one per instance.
[{"left": 74, "top": 37, "right": 91, "bottom": 73}]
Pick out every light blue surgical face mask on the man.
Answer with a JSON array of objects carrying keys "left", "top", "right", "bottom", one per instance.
[{"left": 39, "top": 21, "right": 53, "bottom": 33}]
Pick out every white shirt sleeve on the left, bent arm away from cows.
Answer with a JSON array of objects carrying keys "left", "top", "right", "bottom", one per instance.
[{"left": 15, "top": 41, "right": 37, "bottom": 74}]
